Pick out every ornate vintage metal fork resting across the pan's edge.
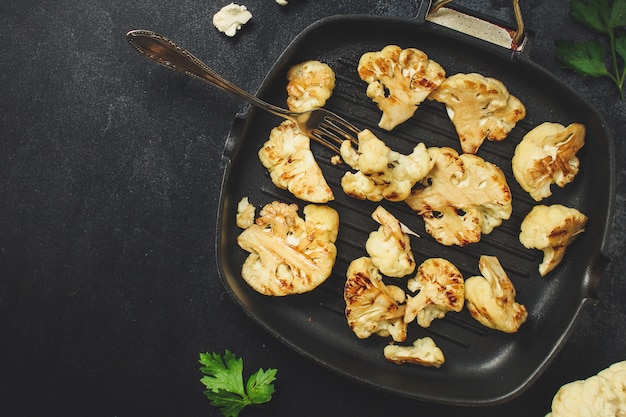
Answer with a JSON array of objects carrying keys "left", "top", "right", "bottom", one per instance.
[{"left": 126, "top": 30, "right": 360, "bottom": 153}]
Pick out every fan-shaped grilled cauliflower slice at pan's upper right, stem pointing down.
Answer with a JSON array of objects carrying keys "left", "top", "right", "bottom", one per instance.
[{"left": 429, "top": 73, "right": 526, "bottom": 154}]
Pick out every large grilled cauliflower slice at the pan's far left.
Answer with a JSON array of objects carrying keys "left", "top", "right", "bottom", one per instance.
[{"left": 237, "top": 201, "right": 339, "bottom": 296}]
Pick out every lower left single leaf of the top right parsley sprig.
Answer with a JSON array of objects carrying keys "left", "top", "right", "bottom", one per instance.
[{"left": 555, "top": 41, "right": 609, "bottom": 77}]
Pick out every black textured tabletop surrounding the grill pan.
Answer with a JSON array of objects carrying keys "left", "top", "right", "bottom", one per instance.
[{"left": 0, "top": 0, "right": 626, "bottom": 416}]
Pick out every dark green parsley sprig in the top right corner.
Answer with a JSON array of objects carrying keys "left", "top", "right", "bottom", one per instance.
[{"left": 555, "top": 0, "right": 626, "bottom": 101}]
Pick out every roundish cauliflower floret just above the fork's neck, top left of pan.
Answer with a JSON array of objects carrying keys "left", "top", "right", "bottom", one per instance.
[{"left": 287, "top": 60, "right": 335, "bottom": 112}]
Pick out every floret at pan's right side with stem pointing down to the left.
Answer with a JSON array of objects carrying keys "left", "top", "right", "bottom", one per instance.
[{"left": 519, "top": 204, "right": 587, "bottom": 277}]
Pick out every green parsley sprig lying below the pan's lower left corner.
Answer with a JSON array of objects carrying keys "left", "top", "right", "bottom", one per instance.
[{"left": 199, "top": 350, "right": 277, "bottom": 417}]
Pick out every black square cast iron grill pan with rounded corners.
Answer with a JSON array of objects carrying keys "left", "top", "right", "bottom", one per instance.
[{"left": 216, "top": 12, "right": 614, "bottom": 405}]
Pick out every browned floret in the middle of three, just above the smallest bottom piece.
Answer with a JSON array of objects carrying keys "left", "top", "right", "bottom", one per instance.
[{"left": 404, "top": 258, "right": 465, "bottom": 327}]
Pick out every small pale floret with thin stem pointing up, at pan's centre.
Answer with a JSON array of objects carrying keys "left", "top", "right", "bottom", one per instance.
[{"left": 365, "top": 206, "right": 415, "bottom": 278}]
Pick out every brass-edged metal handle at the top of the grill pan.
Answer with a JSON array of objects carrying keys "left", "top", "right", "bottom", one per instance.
[{"left": 418, "top": 0, "right": 527, "bottom": 52}]
